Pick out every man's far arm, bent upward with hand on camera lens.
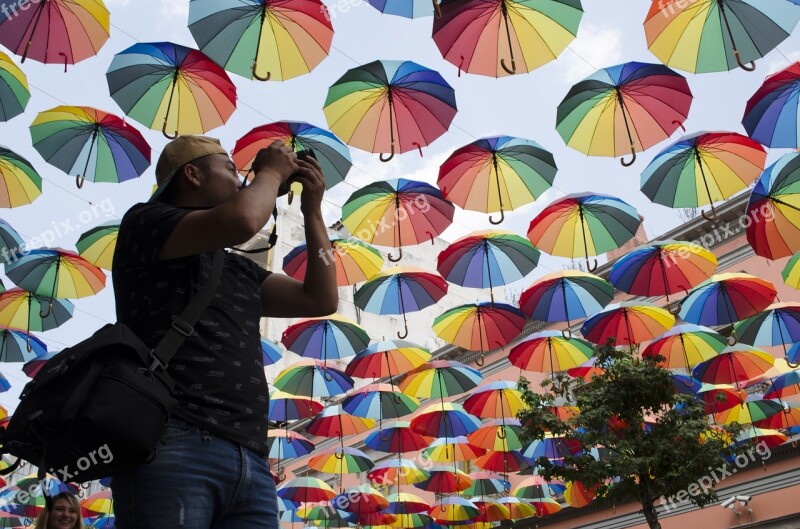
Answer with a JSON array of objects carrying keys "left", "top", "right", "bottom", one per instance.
[{"left": 261, "top": 154, "right": 339, "bottom": 318}]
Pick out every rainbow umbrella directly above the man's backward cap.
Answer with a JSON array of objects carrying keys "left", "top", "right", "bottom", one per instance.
[{"left": 106, "top": 42, "right": 236, "bottom": 138}]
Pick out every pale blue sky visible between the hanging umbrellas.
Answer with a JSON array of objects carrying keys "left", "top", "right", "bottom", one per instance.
[{"left": 0, "top": 0, "right": 800, "bottom": 411}]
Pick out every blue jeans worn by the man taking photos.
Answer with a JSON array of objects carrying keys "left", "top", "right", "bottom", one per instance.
[{"left": 111, "top": 418, "right": 280, "bottom": 529}]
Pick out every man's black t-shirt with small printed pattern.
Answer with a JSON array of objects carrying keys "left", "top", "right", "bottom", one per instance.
[{"left": 112, "top": 202, "right": 270, "bottom": 453}]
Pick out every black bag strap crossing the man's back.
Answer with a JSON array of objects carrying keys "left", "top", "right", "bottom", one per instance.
[{"left": 150, "top": 250, "right": 225, "bottom": 371}]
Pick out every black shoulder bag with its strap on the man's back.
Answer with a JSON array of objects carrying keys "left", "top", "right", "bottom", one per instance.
[{"left": 0, "top": 250, "right": 225, "bottom": 482}]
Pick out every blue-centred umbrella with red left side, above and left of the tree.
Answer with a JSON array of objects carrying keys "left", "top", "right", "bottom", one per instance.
[{"left": 519, "top": 270, "right": 614, "bottom": 336}]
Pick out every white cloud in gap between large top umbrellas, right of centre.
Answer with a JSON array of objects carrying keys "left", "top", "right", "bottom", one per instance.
[{"left": 559, "top": 22, "right": 623, "bottom": 84}]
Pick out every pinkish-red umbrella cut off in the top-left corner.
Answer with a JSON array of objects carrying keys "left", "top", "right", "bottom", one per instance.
[{"left": 0, "top": 0, "right": 110, "bottom": 67}]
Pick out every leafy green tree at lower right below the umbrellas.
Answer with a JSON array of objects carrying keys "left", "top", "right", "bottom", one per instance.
[{"left": 518, "top": 346, "right": 748, "bottom": 529}]
